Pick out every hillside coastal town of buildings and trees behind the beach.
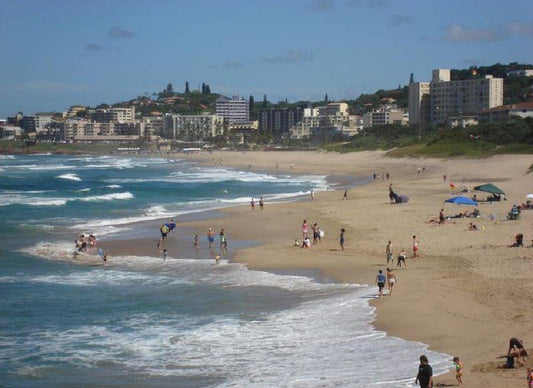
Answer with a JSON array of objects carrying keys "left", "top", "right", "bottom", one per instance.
[{"left": 0, "top": 65, "right": 533, "bottom": 151}]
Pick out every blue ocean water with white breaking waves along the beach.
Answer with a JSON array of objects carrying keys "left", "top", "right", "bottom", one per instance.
[{"left": 0, "top": 155, "right": 451, "bottom": 387}]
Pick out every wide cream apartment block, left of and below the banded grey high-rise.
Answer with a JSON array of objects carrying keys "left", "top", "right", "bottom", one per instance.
[{"left": 162, "top": 114, "right": 225, "bottom": 141}]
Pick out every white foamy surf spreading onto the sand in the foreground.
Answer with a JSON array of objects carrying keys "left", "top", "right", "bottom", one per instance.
[{"left": 0, "top": 257, "right": 456, "bottom": 387}]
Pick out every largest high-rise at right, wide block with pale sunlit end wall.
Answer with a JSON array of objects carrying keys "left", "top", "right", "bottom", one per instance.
[{"left": 430, "top": 69, "right": 503, "bottom": 124}]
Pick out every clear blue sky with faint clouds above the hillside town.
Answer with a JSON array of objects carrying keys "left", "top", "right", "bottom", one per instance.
[{"left": 0, "top": 0, "right": 533, "bottom": 118}]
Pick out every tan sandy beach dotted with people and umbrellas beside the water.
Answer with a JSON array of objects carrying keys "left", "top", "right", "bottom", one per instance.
[{"left": 107, "top": 151, "right": 533, "bottom": 387}]
